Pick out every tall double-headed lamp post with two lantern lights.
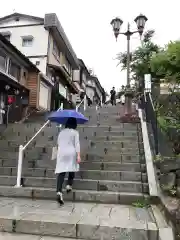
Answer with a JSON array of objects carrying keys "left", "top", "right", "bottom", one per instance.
[{"left": 111, "top": 14, "right": 148, "bottom": 114}]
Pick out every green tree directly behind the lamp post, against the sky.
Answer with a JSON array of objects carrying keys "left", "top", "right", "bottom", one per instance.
[{"left": 116, "top": 30, "right": 160, "bottom": 80}]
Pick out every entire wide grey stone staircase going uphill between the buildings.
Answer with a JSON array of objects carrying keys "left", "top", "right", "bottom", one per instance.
[{"left": 0, "top": 106, "right": 174, "bottom": 240}]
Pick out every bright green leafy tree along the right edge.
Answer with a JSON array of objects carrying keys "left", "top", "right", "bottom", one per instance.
[{"left": 150, "top": 41, "right": 180, "bottom": 145}]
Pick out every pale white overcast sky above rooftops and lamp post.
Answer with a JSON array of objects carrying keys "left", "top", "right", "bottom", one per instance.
[{"left": 0, "top": 0, "right": 180, "bottom": 91}]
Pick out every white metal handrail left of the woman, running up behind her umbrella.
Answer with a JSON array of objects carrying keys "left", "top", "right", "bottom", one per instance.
[{"left": 16, "top": 103, "right": 63, "bottom": 187}]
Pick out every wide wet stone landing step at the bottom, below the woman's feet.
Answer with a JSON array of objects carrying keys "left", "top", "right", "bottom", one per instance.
[{"left": 0, "top": 198, "right": 158, "bottom": 240}]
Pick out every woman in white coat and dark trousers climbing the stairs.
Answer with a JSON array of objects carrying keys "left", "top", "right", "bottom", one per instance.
[{"left": 55, "top": 118, "right": 81, "bottom": 204}]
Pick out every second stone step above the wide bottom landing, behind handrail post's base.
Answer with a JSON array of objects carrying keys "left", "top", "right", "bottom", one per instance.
[{"left": 0, "top": 176, "right": 149, "bottom": 193}]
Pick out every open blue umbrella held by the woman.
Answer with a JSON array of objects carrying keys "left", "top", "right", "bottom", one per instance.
[{"left": 48, "top": 110, "right": 88, "bottom": 124}]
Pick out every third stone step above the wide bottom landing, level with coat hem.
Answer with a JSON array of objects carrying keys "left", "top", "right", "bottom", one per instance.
[{"left": 0, "top": 167, "right": 147, "bottom": 182}]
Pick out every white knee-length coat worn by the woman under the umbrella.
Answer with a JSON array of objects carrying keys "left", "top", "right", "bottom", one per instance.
[{"left": 55, "top": 128, "right": 80, "bottom": 173}]
